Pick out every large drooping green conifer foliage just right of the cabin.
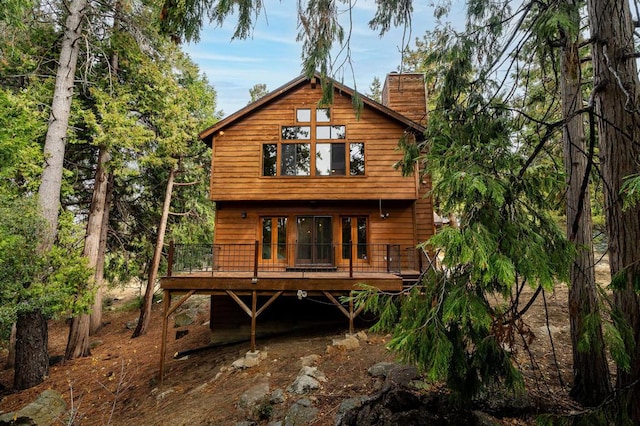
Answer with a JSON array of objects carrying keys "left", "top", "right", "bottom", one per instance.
[{"left": 357, "top": 7, "right": 575, "bottom": 400}]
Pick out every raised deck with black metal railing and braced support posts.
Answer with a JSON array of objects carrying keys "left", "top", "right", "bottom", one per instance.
[{"left": 160, "top": 244, "right": 419, "bottom": 380}]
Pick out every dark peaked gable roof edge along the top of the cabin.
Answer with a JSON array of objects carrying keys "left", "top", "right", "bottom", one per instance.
[{"left": 198, "top": 74, "right": 426, "bottom": 146}]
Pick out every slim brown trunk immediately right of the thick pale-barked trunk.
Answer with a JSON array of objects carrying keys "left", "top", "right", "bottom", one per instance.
[{"left": 65, "top": 147, "right": 110, "bottom": 359}]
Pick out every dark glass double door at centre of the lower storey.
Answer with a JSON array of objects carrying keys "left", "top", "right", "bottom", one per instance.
[{"left": 296, "top": 216, "right": 333, "bottom": 265}]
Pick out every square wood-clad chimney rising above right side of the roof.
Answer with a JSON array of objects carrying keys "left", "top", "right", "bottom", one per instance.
[{"left": 382, "top": 72, "right": 427, "bottom": 126}]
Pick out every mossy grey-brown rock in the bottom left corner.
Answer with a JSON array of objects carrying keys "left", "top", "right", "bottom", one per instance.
[{"left": 0, "top": 389, "right": 67, "bottom": 426}]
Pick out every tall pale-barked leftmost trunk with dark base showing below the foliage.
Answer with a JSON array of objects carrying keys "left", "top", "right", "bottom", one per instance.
[{"left": 14, "top": 0, "right": 87, "bottom": 389}]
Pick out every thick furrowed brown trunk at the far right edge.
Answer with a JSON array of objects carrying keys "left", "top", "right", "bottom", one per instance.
[{"left": 587, "top": 0, "right": 640, "bottom": 424}]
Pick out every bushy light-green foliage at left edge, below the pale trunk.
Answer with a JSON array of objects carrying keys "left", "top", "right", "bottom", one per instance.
[{"left": 0, "top": 195, "right": 93, "bottom": 337}]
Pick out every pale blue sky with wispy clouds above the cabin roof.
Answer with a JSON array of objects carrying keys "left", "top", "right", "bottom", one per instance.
[{"left": 184, "top": 0, "right": 448, "bottom": 116}]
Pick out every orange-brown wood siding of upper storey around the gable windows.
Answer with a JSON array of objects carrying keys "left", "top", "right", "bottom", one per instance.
[{"left": 211, "top": 84, "right": 417, "bottom": 201}]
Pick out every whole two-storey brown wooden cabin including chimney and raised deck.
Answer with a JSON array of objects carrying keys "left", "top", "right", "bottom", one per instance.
[{"left": 161, "top": 73, "right": 434, "bottom": 380}]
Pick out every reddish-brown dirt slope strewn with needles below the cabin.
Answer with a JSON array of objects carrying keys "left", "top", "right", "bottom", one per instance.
[{"left": 0, "top": 258, "right": 607, "bottom": 425}]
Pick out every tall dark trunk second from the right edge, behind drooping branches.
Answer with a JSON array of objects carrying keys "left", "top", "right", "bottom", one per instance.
[{"left": 560, "top": 8, "right": 612, "bottom": 407}]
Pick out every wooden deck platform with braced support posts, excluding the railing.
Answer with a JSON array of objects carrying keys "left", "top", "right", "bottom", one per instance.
[{"left": 160, "top": 271, "right": 404, "bottom": 382}]
